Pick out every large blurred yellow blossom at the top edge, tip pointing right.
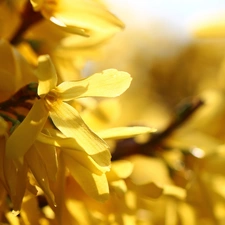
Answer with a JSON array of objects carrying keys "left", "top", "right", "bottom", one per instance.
[{"left": 31, "top": 0, "right": 124, "bottom": 43}]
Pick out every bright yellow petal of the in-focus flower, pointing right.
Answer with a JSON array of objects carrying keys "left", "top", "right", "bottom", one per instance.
[{"left": 57, "top": 69, "right": 132, "bottom": 101}]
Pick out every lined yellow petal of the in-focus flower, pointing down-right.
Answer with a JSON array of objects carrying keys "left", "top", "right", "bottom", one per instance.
[{"left": 49, "top": 101, "right": 111, "bottom": 166}]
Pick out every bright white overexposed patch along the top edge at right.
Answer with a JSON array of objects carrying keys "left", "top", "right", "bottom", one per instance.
[{"left": 106, "top": 0, "right": 225, "bottom": 35}]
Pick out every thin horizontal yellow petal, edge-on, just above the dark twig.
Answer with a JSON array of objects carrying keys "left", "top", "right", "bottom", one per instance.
[{"left": 96, "top": 126, "right": 156, "bottom": 139}]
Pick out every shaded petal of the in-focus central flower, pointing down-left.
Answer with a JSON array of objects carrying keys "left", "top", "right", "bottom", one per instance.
[{"left": 6, "top": 99, "right": 48, "bottom": 158}]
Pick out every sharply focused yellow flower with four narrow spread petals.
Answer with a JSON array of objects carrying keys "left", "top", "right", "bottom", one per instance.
[{"left": 7, "top": 56, "right": 131, "bottom": 158}]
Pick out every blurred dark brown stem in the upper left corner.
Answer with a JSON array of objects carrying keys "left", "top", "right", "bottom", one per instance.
[{"left": 10, "top": 1, "right": 43, "bottom": 45}]
